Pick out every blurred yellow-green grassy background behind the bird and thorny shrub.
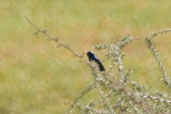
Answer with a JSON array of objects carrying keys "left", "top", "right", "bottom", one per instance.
[{"left": 0, "top": 0, "right": 171, "bottom": 114}]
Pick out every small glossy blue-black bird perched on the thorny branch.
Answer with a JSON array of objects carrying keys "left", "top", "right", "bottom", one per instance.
[{"left": 87, "top": 51, "right": 105, "bottom": 71}]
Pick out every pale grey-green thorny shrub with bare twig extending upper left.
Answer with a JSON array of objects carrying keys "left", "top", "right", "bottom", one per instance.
[{"left": 24, "top": 16, "right": 171, "bottom": 114}]
